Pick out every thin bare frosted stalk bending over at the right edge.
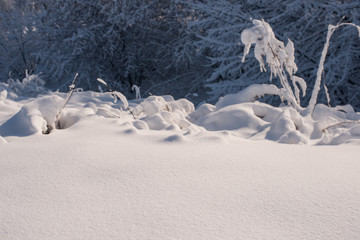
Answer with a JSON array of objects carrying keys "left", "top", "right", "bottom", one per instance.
[{"left": 304, "top": 23, "right": 360, "bottom": 115}]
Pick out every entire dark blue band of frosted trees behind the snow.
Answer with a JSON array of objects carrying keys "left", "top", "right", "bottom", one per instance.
[{"left": 0, "top": 0, "right": 360, "bottom": 111}]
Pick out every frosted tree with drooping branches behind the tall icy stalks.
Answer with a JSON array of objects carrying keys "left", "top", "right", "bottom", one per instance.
[{"left": 189, "top": 0, "right": 360, "bottom": 109}]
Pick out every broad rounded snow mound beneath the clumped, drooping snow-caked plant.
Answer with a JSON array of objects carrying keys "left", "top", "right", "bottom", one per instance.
[{"left": 195, "top": 102, "right": 308, "bottom": 144}]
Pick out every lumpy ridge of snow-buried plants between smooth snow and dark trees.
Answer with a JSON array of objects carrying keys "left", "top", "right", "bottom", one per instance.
[{"left": 0, "top": 87, "right": 360, "bottom": 145}]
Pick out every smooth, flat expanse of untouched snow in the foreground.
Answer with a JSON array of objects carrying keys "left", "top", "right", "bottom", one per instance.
[{"left": 0, "top": 118, "right": 360, "bottom": 240}]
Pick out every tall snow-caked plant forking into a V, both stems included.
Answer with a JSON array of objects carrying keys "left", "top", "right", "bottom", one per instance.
[{"left": 241, "top": 20, "right": 360, "bottom": 119}]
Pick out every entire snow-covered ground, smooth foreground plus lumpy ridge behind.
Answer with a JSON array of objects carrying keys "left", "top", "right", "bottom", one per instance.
[{"left": 0, "top": 85, "right": 360, "bottom": 240}]
